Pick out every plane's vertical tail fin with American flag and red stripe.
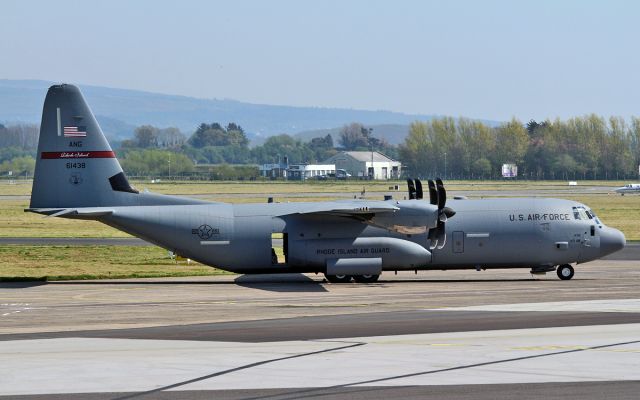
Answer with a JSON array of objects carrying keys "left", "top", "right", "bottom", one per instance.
[{"left": 30, "top": 84, "right": 137, "bottom": 209}]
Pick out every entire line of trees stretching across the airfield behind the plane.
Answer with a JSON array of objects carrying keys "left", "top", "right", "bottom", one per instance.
[{"left": 5, "top": 114, "right": 640, "bottom": 179}]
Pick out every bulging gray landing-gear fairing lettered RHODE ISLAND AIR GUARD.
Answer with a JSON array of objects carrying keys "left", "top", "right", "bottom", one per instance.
[{"left": 288, "top": 237, "right": 431, "bottom": 271}]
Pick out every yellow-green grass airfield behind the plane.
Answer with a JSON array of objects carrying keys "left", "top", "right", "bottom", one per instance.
[{"left": 0, "top": 181, "right": 640, "bottom": 280}]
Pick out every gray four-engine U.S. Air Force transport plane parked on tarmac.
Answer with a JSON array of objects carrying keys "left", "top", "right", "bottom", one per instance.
[{"left": 26, "top": 85, "right": 625, "bottom": 282}]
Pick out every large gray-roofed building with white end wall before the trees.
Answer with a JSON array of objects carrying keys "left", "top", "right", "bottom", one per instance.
[{"left": 324, "top": 151, "right": 402, "bottom": 179}]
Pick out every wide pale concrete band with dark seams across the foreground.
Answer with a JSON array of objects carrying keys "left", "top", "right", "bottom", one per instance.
[{"left": 0, "top": 324, "right": 640, "bottom": 395}]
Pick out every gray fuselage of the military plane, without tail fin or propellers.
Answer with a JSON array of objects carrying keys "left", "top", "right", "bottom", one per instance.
[{"left": 101, "top": 198, "right": 624, "bottom": 273}]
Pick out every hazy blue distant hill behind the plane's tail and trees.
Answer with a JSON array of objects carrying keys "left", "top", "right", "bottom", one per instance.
[{"left": 0, "top": 80, "right": 448, "bottom": 143}]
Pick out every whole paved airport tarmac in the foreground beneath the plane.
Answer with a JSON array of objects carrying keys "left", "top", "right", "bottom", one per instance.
[{"left": 0, "top": 260, "right": 640, "bottom": 399}]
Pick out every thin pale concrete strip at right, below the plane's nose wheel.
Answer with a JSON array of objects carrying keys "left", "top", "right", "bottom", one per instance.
[{"left": 438, "top": 299, "right": 640, "bottom": 313}]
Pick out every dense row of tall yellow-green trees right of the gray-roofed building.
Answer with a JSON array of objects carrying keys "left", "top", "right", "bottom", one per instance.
[{"left": 399, "top": 114, "right": 640, "bottom": 179}]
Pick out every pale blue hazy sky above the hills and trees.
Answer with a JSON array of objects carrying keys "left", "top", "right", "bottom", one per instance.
[{"left": 0, "top": 0, "right": 640, "bottom": 120}]
